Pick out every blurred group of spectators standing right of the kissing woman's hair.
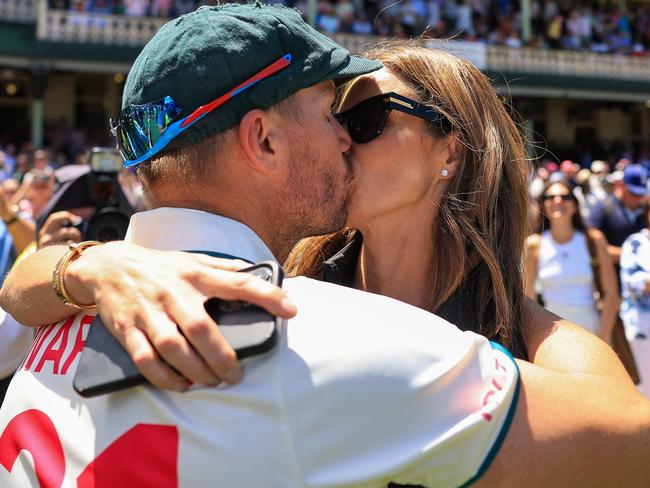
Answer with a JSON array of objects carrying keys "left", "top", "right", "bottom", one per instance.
[{"left": 524, "top": 159, "right": 650, "bottom": 396}]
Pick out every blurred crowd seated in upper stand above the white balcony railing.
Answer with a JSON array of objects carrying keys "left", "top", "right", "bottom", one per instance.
[{"left": 49, "top": 0, "right": 650, "bottom": 56}]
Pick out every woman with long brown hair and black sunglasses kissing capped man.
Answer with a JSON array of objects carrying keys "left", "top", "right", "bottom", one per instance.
[{"left": 3, "top": 45, "right": 624, "bottom": 384}]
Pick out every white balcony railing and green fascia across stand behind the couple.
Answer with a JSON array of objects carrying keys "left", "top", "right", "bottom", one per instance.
[{"left": 11, "top": 0, "right": 650, "bottom": 102}]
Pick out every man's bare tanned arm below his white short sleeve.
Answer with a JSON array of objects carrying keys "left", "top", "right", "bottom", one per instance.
[{"left": 476, "top": 361, "right": 650, "bottom": 488}]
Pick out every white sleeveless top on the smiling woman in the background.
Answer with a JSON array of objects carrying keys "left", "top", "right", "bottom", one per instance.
[{"left": 537, "top": 231, "right": 594, "bottom": 306}]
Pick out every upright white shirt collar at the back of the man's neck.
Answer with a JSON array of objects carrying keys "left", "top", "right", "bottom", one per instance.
[{"left": 125, "top": 207, "right": 276, "bottom": 263}]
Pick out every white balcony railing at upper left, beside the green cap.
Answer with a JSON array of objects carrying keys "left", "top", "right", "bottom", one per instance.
[{"left": 36, "top": 6, "right": 169, "bottom": 46}]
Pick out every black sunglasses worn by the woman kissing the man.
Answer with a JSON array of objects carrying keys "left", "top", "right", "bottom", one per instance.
[{"left": 334, "top": 92, "right": 451, "bottom": 144}]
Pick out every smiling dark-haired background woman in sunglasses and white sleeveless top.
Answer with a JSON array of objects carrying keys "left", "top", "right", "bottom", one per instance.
[{"left": 525, "top": 181, "right": 620, "bottom": 342}]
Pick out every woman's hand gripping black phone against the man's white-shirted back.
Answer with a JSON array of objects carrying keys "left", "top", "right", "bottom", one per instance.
[{"left": 64, "top": 241, "right": 296, "bottom": 391}]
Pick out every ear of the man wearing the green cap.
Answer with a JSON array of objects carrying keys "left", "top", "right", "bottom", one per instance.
[{"left": 239, "top": 109, "right": 280, "bottom": 173}]
